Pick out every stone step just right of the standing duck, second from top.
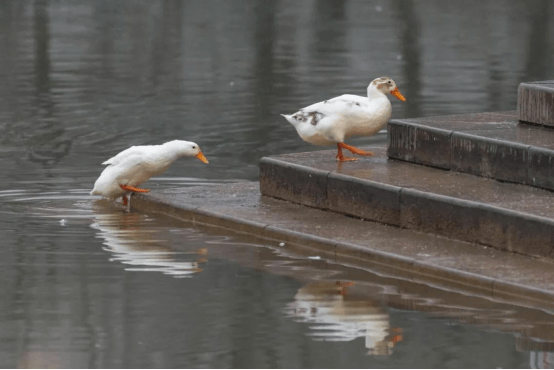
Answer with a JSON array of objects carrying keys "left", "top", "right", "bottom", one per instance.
[{"left": 387, "top": 111, "right": 554, "bottom": 190}]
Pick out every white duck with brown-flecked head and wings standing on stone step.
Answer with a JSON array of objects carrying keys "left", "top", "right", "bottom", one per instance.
[{"left": 282, "top": 77, "right": 406, "bottom": 162}]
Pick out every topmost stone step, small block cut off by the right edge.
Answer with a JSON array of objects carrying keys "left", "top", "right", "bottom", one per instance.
[{"left": 517, "top": 80, "right": 554, "bottom": 127}]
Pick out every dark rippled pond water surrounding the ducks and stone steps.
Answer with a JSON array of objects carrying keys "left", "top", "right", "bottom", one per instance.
[{"left": 0, "top": 1, "right": 554, "bottom": 368}]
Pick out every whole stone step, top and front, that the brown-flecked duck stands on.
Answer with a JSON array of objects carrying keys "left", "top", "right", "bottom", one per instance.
[{"left": 260, "top": 146, "right": 554, "bottom": 258}]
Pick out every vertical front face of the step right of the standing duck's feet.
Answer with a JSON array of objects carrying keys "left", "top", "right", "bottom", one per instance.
[{"left": 387, "top": 120, "right": 554, "bottom": 190}]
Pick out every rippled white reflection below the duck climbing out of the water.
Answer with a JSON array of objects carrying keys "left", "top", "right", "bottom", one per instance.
[{"left": 90, "top": 199, "right": 208, "bottom": 278}]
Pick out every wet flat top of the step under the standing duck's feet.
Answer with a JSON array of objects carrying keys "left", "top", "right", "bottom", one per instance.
[{"left": 272, "top": 146, "right": 554, "bottom": 220}]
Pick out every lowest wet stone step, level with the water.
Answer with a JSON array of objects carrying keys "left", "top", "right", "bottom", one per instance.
[{"left": 131, "top": 182, "right": 554, "bottom": 306}]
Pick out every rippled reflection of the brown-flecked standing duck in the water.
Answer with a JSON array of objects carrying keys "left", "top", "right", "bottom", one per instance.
[{"left": 287, "top": 281, "right": 402, "bottom": 355}]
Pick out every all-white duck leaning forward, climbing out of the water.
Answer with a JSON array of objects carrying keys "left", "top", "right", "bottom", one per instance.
[{"left": 90, "top": 140, "right": 208, "bottom": 205}]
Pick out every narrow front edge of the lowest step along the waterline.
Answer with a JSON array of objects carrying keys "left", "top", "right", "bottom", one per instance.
[{"left": 131, "top": 194, "right": 554, "bottom": 310}]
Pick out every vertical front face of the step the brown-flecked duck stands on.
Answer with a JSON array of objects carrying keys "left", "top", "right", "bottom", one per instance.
[{"left": 260, "top": 158, "right": 554, "bottom": 257}]
